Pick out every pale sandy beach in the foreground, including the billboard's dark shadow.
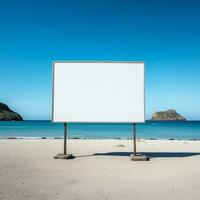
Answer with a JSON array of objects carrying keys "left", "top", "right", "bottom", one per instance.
[{"left": 0, "top": 139, "right": 200, "bottom": 200}]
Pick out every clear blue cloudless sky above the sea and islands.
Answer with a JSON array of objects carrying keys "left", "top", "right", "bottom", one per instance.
[{"left": 0, "top": 0, "right": 200, "bottom": 120}]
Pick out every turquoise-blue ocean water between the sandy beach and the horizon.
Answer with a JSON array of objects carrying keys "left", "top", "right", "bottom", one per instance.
[{"left": 0, "top": 121, "right": 200, "bottom": 140}]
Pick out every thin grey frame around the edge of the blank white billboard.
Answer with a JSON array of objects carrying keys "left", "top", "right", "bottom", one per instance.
[{"left": 51, "top": 61, "right": 146, "bottom": 124}]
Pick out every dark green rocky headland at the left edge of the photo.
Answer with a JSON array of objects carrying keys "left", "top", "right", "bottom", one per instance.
[{"left": 0, "top": 102, "right": 23, "bottom": 121}]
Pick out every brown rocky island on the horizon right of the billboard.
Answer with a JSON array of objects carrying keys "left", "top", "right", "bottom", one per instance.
[{"left": 151, "top": 109, "right": 186, "bottom": 121}]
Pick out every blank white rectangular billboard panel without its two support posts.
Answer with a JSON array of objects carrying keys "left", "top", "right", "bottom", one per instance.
[{"left": 52, "top": 62, "right": 145, "bottom": 123}]
